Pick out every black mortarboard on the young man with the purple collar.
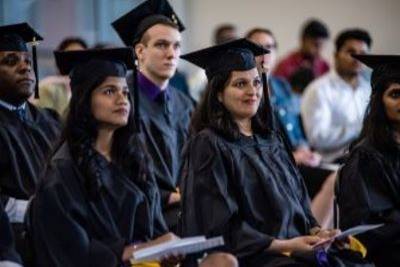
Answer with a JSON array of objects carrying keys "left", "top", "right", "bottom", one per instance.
[{"left": 111, "top": 0, "right": 185, "bottom": 46}]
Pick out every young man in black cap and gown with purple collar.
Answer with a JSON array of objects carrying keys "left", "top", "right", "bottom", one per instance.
[{"left": 112, "top": 0, "right": 193, "bottom": 231}]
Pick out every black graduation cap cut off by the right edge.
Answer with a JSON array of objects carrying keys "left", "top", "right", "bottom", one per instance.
[{"left": 352, "top": 55, "right": 400, "bottom": 91}]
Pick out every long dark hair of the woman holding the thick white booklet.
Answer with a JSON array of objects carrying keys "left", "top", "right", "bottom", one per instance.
[{"left": 62, "top": 71, "right": 149, "bottom": 197}]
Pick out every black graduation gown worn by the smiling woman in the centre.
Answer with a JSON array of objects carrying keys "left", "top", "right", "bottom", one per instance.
[{"left": 181, "top": 129, "right": 317, "bottom": 266}]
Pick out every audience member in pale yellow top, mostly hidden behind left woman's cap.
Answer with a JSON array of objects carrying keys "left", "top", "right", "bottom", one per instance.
[{"left": 33, "top": 37, "right": 88, "bottom": 117}]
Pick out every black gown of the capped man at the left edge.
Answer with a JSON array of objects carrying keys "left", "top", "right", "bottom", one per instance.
[{"left": 0, "top": 103, "right": 61, "bottom": 200}]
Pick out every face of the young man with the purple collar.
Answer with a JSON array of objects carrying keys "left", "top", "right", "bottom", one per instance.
[{"left": 135, "top": 24, "right": 181, "bottom": 83}]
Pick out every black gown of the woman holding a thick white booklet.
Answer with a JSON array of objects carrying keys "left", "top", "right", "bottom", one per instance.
[{"left": 29, "top": 144, "right": 167, "bottom": 267}]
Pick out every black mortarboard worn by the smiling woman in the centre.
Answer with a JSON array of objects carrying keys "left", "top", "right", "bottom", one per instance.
[{"left": 181, "top": 38, "right": 269, "bottom": 80}]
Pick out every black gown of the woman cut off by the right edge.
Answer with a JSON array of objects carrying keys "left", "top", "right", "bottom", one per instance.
[{"left": 337, "top": 140, "right": 400, "bottom": 266}]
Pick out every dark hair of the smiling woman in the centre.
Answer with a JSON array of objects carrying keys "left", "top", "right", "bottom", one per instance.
[{"left": 190, "top": 72, "right": 271, "bottom": 140}]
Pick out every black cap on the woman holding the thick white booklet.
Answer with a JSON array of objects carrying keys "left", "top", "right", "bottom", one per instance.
[{"left": 54, "top": 47, "right": 139, "bottom": 132}]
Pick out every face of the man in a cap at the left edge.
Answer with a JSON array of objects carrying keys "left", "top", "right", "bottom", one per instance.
[{"left": 0, "top": 51, "right": 36, "bottom": 104}]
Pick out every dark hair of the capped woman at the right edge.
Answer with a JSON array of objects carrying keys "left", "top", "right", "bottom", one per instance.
[{"left": 350, "top": 77, "right": 400, "bottom": 153}]
